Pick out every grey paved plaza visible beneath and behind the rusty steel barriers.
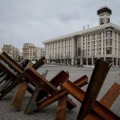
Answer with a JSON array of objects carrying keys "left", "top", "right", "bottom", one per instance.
[{"left": 0, "top": 66, "right": 120, "bottom": 120}]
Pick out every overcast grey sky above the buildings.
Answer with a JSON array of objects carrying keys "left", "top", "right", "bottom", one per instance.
[{"left": 0, "top": 0, "right": 120, "bottom": 50}]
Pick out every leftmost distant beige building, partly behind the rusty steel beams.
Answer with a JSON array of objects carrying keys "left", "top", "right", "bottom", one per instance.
[{"left": 2, "top": 44, "right": 19, "bottom": 61}]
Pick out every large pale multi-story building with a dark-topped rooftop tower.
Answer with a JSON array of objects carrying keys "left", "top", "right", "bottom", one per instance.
[{"left": 44, "top": 6, "right": 120, "bottom": 66}]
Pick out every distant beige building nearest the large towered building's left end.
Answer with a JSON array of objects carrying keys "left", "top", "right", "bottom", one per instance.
[{"left": 22, "top": 43, "right": 43, "bottom": 60}]
